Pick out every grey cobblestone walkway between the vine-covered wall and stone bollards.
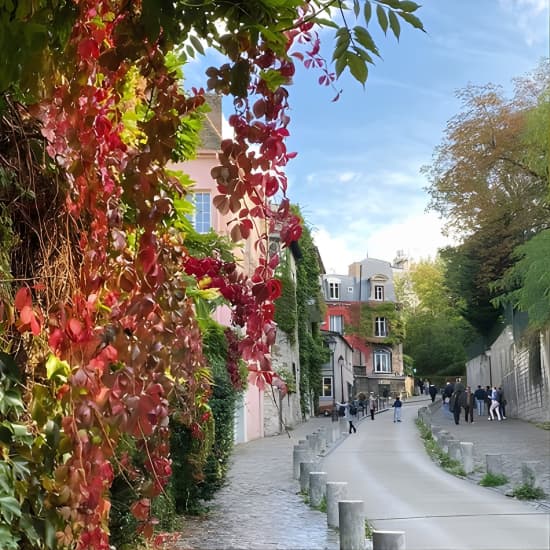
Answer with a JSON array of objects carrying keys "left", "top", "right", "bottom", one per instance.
[{"left": 175, "top": 418, "right": 338, "bottom": 550}]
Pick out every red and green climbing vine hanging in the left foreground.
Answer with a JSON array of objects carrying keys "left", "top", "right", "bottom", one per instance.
[{"left": 0, "top": 0, "right": 422, "bottom": 550}]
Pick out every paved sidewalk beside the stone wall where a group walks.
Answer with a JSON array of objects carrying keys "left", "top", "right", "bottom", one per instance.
[{"left": 426, "top": 396, "right": 550, "bottom": 509}]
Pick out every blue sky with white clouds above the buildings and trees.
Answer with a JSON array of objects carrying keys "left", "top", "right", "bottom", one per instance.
[{"left": 186, "top": 0, "right": 549, "bottom": 273}]
